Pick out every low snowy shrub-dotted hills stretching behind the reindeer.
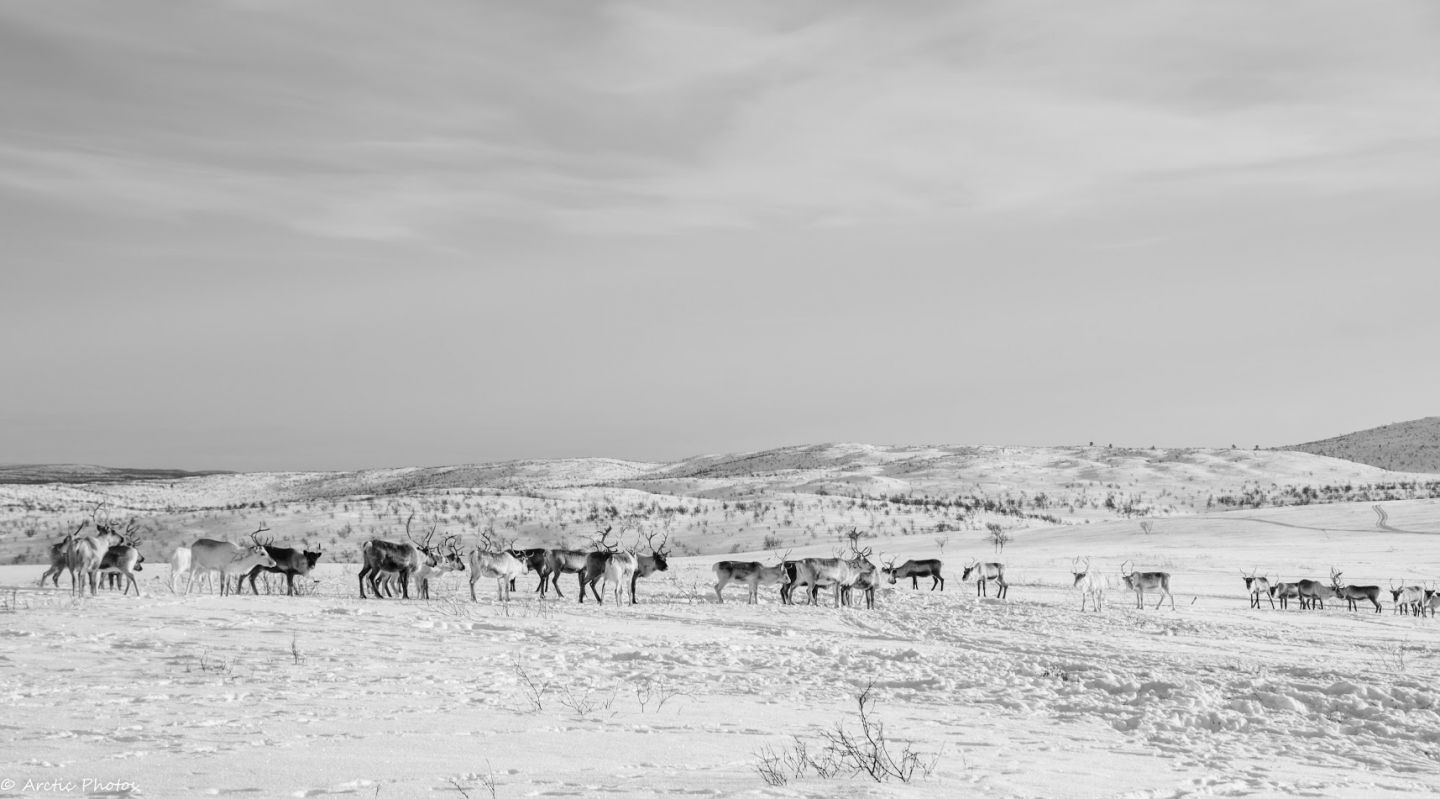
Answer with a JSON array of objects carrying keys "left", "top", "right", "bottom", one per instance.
[{"left": 0, "top": 443, "right": 1440, "bottom": 563}]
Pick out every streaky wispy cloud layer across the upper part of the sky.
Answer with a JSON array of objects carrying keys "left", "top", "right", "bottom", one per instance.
[{"left": 0, "top": 1, "right": 1440, "bottom": 239}]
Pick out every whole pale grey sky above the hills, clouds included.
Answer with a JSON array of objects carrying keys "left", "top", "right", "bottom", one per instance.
[{"left": 0, "top": 0, "right": 1440, "bottom": 471}]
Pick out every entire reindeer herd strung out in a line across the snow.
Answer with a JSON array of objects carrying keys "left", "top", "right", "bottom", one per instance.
[{"left": 40, "top": 514, "right": 1440, "bottom": 618}]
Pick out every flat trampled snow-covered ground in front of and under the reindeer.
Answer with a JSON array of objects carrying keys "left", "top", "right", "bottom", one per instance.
[{"left": 0, "top": 501, "right": 1440, "bottom": 799}]
